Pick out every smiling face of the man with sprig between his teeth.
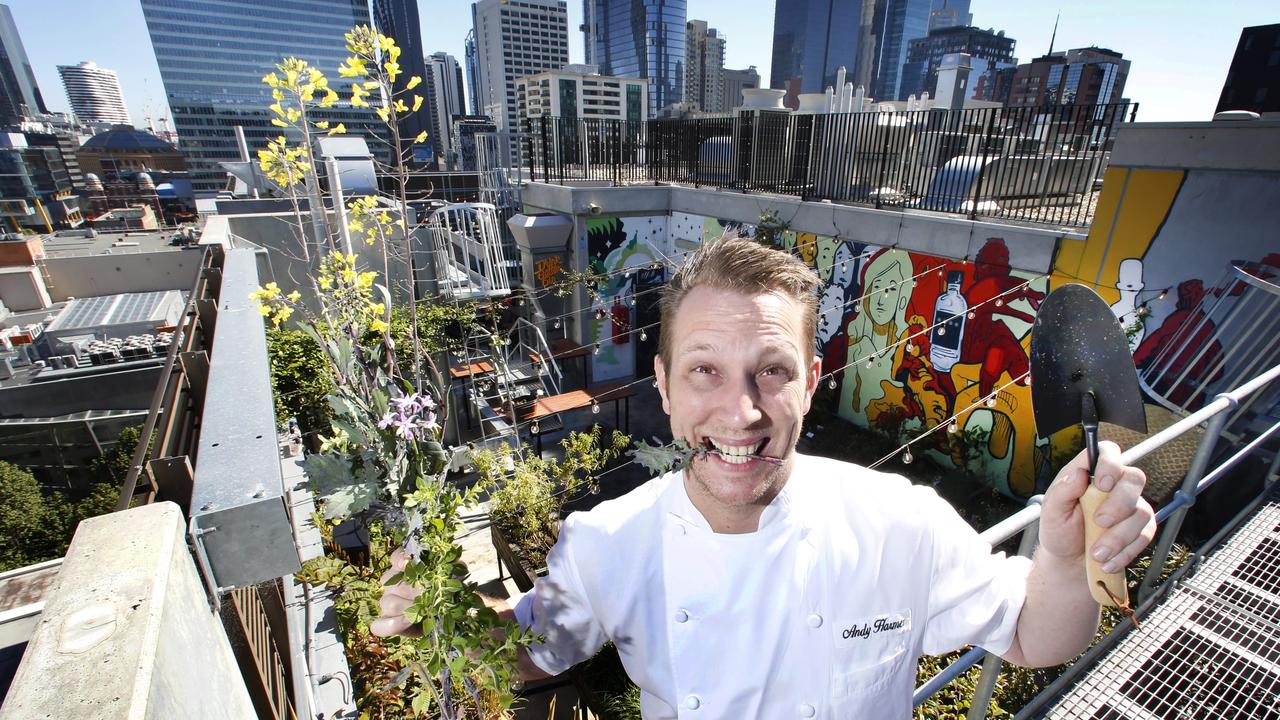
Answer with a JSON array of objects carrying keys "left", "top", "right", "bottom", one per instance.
[{"left": 654, "top": 287, "right": 819, "bottom": 511}]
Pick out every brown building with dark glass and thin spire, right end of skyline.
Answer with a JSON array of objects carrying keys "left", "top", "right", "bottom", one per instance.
[{"left": 1006, "top": 47, "right": 1129, "bottom": 108}]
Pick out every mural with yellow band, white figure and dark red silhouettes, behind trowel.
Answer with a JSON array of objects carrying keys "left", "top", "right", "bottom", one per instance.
[{"left": 1053, "top": 167, "right": 1280, "bottom": 407}]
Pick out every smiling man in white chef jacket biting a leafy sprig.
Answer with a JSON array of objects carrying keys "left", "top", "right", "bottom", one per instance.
[{"left": 374, "top": 238, "right": 1155, "bottom": 720}]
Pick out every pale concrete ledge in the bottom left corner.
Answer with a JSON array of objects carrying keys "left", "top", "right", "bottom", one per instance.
[{"left": 0, "top": 502, "right": 256, "bottom": 720}]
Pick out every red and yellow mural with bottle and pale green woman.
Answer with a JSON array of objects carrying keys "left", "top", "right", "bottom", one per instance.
[{"left": 787, "top": 233, "right": 1047, "bottom": 496}]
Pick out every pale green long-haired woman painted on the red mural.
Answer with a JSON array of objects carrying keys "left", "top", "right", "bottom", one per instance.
[{"left": 841, "top": 250, "right": 915, "bottom": 415}]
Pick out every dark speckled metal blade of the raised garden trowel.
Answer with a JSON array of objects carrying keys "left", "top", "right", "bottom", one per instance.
[{"left": 1030, "top": 284, "right": 1147, "bottom": 437}]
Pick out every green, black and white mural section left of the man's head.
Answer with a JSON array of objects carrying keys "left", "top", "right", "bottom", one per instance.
[{"left": 581, "top": 215, "right": 673, "bottom": 382}]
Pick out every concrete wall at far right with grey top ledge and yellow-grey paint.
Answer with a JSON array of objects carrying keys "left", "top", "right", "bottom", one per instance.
[{"left": 1053, "top": 122, "right": 1280, "bottom": 407}]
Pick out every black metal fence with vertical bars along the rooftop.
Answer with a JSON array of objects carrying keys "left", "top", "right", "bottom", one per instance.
[{"left": 521, "top": 102, "right": 1138, "bottom": 225}]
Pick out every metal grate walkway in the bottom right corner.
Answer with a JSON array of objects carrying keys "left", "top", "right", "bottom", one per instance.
[{"left": 1044, "top": 489, "right": 1280, "bottom": 720}]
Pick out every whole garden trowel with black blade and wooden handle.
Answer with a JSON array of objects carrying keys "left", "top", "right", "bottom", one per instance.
[{"left": 1032, "top": 284, "right": 1147, "bottom": 610}]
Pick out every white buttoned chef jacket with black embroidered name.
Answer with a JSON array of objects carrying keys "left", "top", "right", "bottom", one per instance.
[{"left": 516, "top": 455, "right": 1030, "bottom": 720}]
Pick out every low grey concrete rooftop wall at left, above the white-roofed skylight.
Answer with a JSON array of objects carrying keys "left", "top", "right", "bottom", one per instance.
[{"left": 45, "top": 247, "right": 201, "bottom": 301}]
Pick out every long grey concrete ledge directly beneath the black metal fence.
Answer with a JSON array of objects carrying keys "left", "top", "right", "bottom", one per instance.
[{"left": 522, "top": 183, "right": 1070, "bottom": 273}]
